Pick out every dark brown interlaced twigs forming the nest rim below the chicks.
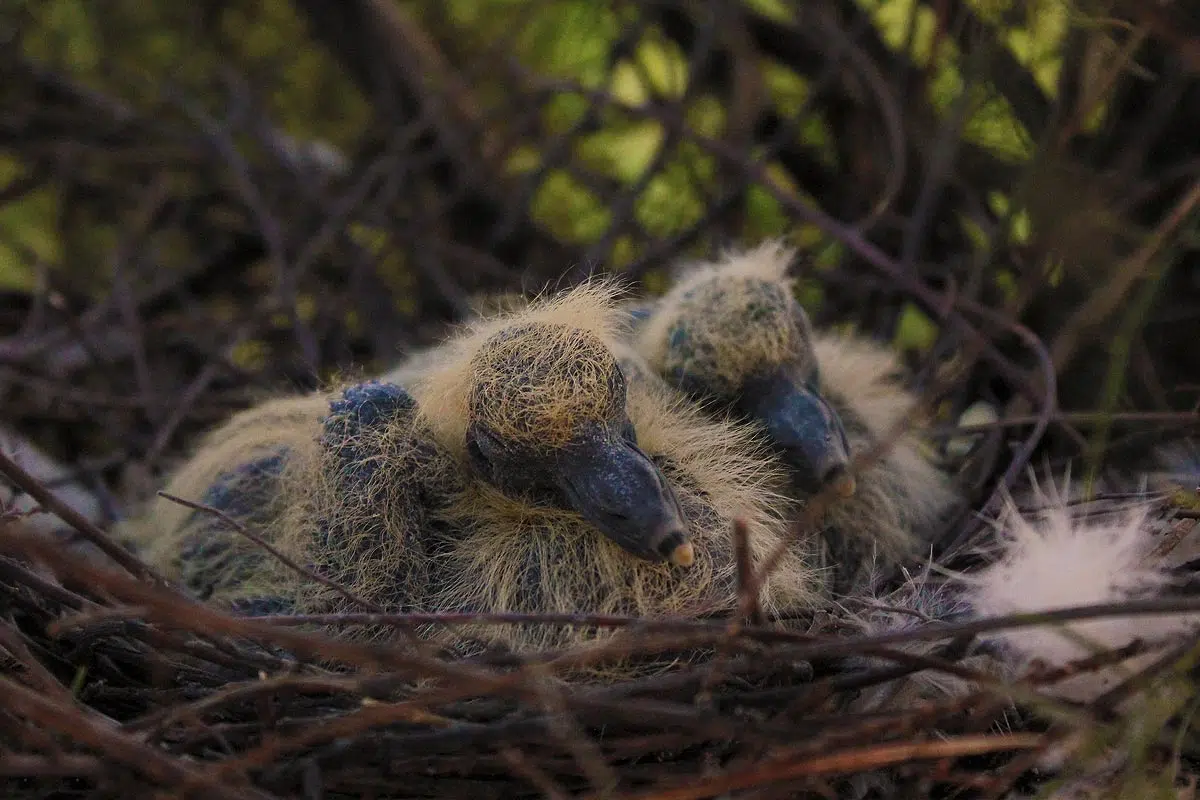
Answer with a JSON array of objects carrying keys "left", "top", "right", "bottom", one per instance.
[{"left": 0, "top": 489, "right": 1194, "bottom": 798}]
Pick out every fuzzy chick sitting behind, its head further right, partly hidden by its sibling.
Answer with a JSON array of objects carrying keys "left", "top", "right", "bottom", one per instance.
[{"left": 628, "top": 242, "right": 956, "bottom": 578}]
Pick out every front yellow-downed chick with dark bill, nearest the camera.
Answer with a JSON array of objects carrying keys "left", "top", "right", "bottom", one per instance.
[{"left": 134, "top": 283, "right": 820, "bottom": 650}]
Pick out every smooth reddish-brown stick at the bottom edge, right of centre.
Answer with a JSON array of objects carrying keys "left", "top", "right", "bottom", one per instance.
[{"left": 588, "top": 734, "right": 1043, "bottom": 800}]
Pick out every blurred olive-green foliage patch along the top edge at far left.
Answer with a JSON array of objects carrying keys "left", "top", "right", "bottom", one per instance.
[{"left": 23, "top": 0, "right": 370, "bottom": 146}]
